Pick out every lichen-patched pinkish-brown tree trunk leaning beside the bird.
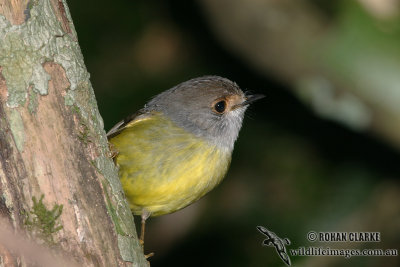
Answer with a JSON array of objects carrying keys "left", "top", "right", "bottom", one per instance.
[{"left": 0, "top": 0, "right": 148, "bottom": 266}]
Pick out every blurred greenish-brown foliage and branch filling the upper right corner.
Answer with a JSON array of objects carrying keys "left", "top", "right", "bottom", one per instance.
[{"left": 200, "top": 0, "right": 400, "bottom": 148}]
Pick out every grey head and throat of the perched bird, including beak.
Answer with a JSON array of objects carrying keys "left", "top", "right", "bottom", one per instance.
[{"left": 145, "top": 76, "right": 262, "bottom": 152}]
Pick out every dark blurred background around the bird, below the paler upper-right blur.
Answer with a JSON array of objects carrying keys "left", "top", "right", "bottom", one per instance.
[{"left": 68, "top": 0, "right": 400, "bottom": 267}]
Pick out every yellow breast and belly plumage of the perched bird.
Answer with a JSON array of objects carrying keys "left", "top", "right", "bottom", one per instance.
[{"left": 110, "top": 114, "right": 231, "bottom": 216}]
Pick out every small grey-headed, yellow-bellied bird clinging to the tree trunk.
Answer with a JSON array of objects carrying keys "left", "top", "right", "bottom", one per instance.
[{"left": 107, "top": 76, "right": 264, "bottom": 250}]
